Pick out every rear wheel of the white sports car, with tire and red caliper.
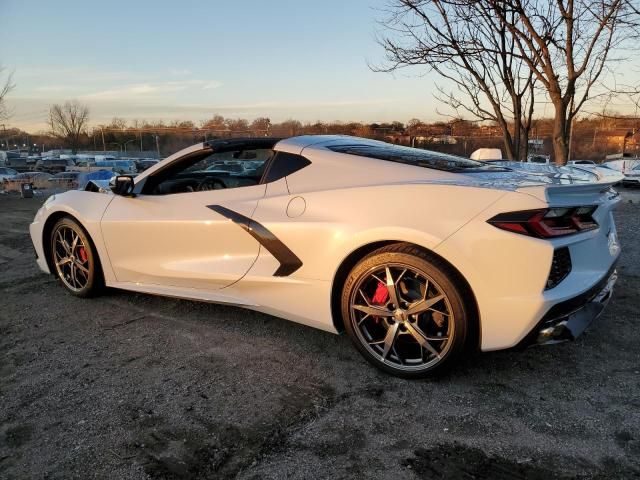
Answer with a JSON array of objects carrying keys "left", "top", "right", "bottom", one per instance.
[{"left": 341, "top": 243, "right": 475, "bottom": 378}]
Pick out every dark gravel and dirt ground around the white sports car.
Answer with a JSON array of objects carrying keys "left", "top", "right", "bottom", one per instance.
[{"left": 0, "top": 189, "right": 640, "bottom": 479}]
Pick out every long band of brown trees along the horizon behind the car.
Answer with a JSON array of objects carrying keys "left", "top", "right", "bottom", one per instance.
[{"left": 6, "top": 107, "right": 640, "bottom": 161}]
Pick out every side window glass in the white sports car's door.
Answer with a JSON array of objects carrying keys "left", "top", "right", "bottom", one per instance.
[{"left": 144, "top": 148, "right": 273, "bottom": 195}]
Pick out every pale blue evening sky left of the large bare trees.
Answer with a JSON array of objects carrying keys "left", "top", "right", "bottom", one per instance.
[{"left": 0, "top": 0, "right": 450, "bottom": 131}]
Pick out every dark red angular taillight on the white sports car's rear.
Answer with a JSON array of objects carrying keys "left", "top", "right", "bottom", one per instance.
[{"left": 487, "top": 205, "right": 598, "bottom": 238}]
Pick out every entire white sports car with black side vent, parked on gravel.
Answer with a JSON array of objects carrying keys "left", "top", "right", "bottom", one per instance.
[{"left": 31, "top": 136, "right": 620, "bottom": 378}]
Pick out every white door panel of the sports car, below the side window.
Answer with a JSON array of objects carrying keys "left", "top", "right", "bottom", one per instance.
[{"left": 101, "top": 185, "right": 265, "bottom": 289}]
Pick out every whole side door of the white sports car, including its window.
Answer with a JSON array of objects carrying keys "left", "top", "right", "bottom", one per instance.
[{"left": 101, "top": 145, "right": 271, "bottom": 289}]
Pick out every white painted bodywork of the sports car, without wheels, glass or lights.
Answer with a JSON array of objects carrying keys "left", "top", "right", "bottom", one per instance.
[{"left": 31, "top": 136, "right": 619, "bottom": 350}]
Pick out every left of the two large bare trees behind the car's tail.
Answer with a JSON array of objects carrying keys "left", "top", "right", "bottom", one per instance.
[{"left": 375, "top": 0, "right": 536, "bottom": 159}]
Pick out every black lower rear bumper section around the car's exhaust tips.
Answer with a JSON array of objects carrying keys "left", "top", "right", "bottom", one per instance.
[{"left": 518, "top": 265, "right": 618, "bottom": 347}]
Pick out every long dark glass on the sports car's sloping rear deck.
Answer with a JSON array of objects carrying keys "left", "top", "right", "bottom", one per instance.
[{"left": 327, "top": 142, "right": 505, "bottom": 172}]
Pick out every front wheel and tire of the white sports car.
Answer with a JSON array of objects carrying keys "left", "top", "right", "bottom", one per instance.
[{"left": 49, "top": 217, "right": 104, "bottom": 298}]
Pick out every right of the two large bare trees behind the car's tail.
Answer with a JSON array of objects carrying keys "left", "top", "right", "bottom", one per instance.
[{"left": 496, "top": 0, "right": 640, "bottom": 165}]
